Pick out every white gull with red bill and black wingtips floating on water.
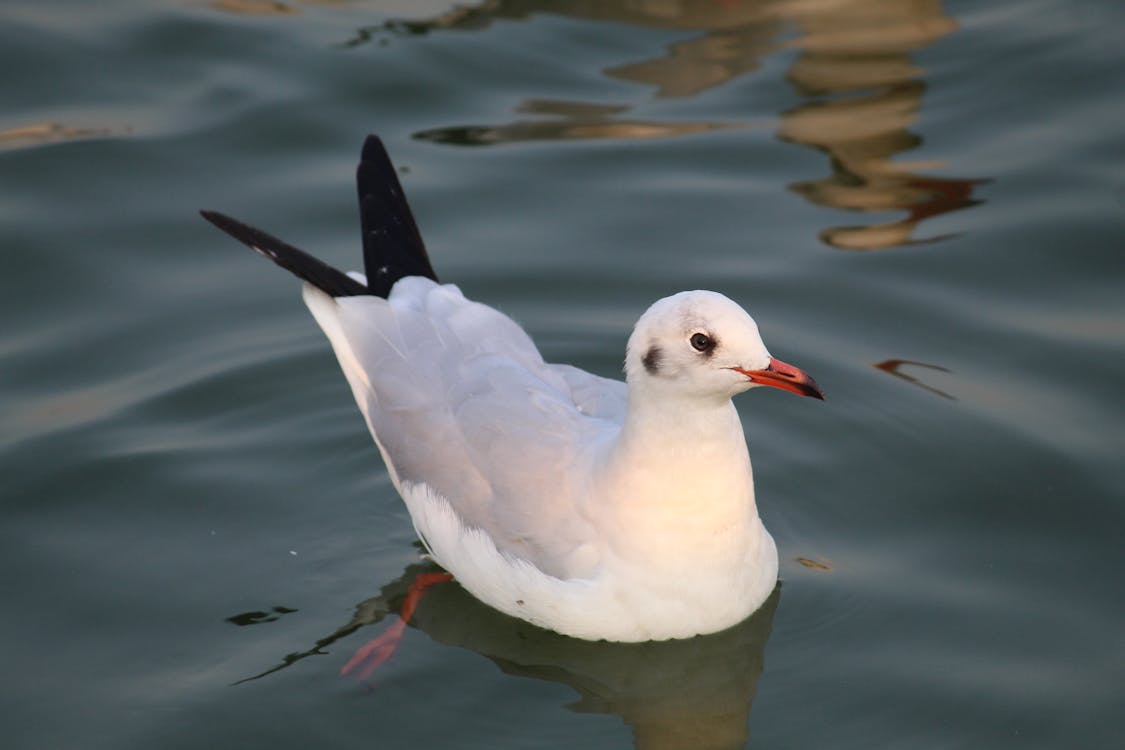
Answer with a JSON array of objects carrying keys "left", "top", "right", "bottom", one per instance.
[{"left": 200, "top": 135, "right": 824, "bottom": 642}]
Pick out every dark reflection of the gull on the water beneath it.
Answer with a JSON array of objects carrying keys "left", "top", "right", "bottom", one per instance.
[{"left": 236, "top": 563, "right": 781, "bottom": 750}]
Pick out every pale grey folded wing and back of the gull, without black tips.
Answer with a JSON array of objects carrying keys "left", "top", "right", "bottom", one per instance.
[{"left": 305, "top": 277, "right": 624, "bottom": 578}]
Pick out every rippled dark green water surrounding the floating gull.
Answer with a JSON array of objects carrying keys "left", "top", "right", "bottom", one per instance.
[{"left": 0, "top": 0, "right": 1125, "bottom": 749}]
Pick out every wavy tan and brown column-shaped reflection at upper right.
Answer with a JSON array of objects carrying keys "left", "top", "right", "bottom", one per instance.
[{"left": 780, "top": 0, "right": 984, "bottom": 250}]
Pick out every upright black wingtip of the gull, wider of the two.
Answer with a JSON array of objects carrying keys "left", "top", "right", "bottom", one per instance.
[{"left": 356, "top": 135, "right": 438, "bottom": 297}]
